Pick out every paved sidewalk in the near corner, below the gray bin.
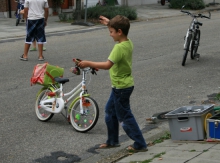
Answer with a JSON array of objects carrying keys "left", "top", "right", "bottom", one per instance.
[{"left": 117, "top": 122, "right": 220, "bottom": 163}]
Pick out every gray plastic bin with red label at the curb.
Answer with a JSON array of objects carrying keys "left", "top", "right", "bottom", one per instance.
[{"left": 165, "top": 105, "right": 214, "bottom": 140}]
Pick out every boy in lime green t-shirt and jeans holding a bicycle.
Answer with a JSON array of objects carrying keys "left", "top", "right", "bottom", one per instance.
[{"left": 78, "top": 15, "right": 147, "bottom": 152}]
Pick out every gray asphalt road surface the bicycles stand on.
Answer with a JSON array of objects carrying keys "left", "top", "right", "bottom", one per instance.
[{"left": 0, "top": 11, "right": 220, "bottom": 163}]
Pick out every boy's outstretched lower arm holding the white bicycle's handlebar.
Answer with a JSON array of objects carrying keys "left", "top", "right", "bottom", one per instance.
[{"left": 78, "top": 60, "right": 114, "bottom": 70}]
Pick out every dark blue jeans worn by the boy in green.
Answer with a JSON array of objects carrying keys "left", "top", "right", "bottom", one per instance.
[{"left": 105, "top": 86, "right": 147, "bottom": 149}]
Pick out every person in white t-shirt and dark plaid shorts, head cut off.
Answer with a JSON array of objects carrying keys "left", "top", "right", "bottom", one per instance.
[{"left": 20, "top": 0, "right": 49, "bottom": 61}]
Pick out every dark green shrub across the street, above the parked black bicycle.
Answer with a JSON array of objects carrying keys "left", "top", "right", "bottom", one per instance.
[{"left": 169, "top": 0, "right": 205, "bottom": 10}]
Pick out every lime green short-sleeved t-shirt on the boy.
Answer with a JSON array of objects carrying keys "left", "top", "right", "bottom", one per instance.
[{"left": 108, "top": 39, "right": 134, "bottom": 89}]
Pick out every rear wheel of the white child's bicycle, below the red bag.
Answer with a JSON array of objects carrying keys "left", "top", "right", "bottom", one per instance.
[{"left": 35, "top": 89, "right": 54, "bottom": 122}]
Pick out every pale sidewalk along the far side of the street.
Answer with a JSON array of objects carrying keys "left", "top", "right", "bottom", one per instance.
[{"left": 0, "top": 3, "right": 220, "bottom": 40}]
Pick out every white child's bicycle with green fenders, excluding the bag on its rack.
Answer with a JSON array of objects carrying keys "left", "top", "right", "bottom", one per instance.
[{"left": 35, "top": 59, "right": 99, "bottom": 132}]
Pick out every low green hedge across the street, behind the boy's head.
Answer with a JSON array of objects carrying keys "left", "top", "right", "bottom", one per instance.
[{"left": 82, "top": 6, "right": 137, "bottom": 20}]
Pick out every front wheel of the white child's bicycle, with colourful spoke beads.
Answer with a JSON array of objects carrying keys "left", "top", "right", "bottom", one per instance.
[{"left": 70, "top": 97, "right": 99, "bottom": 132}]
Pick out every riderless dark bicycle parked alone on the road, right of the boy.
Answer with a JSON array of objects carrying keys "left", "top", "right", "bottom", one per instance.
[{"left": 181, "top": 6, "right": 211, "bottom": 66}]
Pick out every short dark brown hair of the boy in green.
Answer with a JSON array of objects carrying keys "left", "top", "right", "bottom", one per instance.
[{"left": 107, "top": 15, "right": 130, "bottom": 36}]
